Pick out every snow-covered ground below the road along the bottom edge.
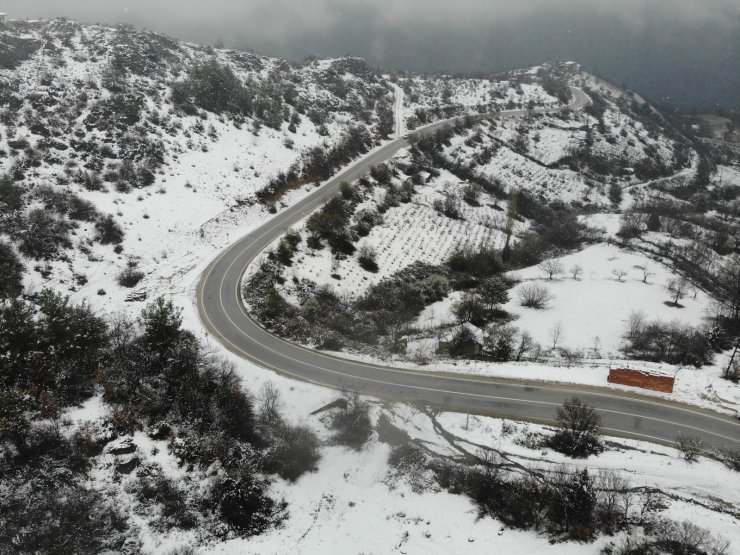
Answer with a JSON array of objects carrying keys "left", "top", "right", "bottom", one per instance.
[{"left": 65, "top": 372, "right": 740, "bottom": 554}]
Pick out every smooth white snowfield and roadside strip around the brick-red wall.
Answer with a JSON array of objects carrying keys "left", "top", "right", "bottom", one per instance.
[{"left": 284, "top": 243, "right": 740, "bottom": 414}]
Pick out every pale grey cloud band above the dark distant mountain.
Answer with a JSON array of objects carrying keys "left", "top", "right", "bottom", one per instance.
[{"left": 7, "top": 0, "right": 740, "bottom": 44}]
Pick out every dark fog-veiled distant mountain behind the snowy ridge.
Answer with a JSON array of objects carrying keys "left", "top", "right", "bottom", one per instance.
[{"left": 262, "top": 9, "right": 740, "bottom": 110}]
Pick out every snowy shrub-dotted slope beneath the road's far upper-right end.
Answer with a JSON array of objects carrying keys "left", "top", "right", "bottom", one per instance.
[{"left": 436, "top": 70, "right": 691, "bottom": 206}]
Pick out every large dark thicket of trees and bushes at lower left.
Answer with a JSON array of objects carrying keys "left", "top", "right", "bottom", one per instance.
[{"left": 0, "top": 291, "right": 300, "bottom": 553}]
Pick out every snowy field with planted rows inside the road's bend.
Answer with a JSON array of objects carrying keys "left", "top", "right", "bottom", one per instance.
[{"left": 274, "top": 159, "right": 506, "bottom": 297}]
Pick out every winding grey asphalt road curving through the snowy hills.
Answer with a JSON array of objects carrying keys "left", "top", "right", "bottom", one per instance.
[{"left": 197, "top": 88, "right": 740, "bottom": 449}]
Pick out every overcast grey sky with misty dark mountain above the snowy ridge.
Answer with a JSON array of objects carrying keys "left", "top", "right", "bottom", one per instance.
[{"left": 5, "top": 0, "right": 740, "bottom": 108}]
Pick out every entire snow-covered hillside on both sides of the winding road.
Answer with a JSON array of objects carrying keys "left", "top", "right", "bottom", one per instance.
[{"left": 0, "top": 19, "right": 740, "bottom": 555}]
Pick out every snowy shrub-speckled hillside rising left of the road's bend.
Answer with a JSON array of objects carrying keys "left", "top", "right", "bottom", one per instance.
[{"left": 0, "top": 20, "right": 393, "bottom": 310}]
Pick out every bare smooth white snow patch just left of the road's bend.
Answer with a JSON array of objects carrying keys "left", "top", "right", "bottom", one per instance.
[{"left": 25, "top": 116, "right": 326, "bottom": 311}]
